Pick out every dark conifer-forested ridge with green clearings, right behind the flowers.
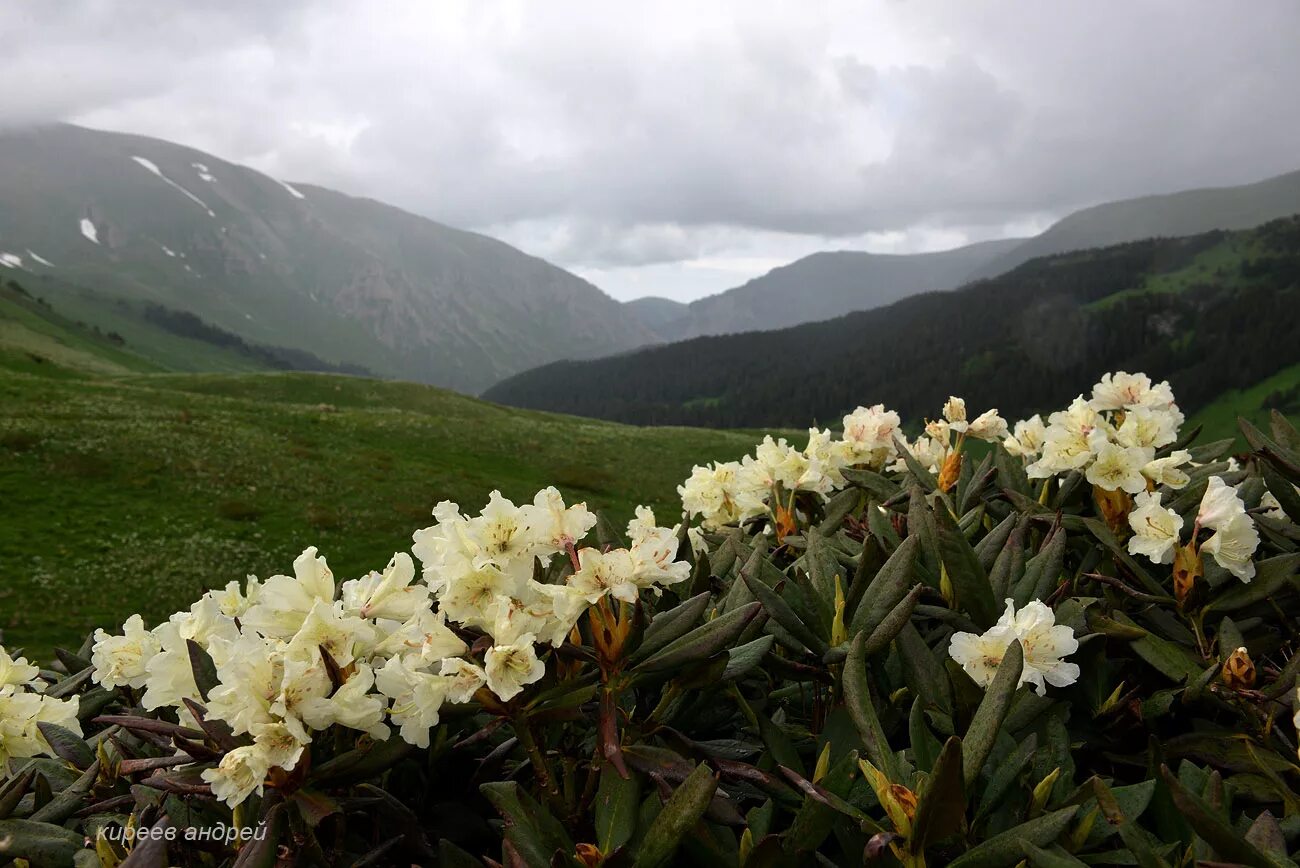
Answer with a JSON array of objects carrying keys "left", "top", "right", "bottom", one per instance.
[{"left": 485, "top": 217, "right": 1300, "bottom": 428}]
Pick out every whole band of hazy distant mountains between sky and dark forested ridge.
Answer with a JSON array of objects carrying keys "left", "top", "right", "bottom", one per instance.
[{"left": 0, "top": 125, "right": 1300, "bottom": 392}]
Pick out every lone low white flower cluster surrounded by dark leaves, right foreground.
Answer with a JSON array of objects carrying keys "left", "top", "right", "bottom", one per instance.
[{"left": 948, "top": 599, "right": 1079, "bottom": 695}]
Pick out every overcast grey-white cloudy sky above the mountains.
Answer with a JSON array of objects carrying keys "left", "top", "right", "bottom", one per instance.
[{"left": 0, "top": 0, "right": 1300, "bottom": 299}]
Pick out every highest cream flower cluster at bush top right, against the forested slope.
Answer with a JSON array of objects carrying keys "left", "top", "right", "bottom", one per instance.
[{"left": 1002, "top": 370, "right": 1191, "bottom": 494}]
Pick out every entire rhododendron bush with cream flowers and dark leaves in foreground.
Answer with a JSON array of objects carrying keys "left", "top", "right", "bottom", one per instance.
[{"left": 0, "top": 372, "right": 1300, "bottom": 868}]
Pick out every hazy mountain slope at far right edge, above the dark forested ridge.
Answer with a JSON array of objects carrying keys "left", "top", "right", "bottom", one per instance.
[{"left": 969, "top": 172, "right": 1300, "bottom": 279}]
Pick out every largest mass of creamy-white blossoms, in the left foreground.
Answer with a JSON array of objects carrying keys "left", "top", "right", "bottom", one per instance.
[{"left": 90, "top": 489, "right": 690, "bottom": 806}]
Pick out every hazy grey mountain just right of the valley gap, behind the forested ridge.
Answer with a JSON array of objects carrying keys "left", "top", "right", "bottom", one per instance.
[{"left": 644, "top": 239, "right": 1022, "bottom": 340}]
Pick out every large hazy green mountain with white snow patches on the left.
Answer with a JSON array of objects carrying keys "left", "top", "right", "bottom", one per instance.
[{"left": 0, "top": 125, "right": 654, "bottom": 391}]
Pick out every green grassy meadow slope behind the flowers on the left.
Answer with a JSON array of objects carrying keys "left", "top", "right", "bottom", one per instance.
[{"left": 0, "top": 370, "right": 757, "bottom": 657}]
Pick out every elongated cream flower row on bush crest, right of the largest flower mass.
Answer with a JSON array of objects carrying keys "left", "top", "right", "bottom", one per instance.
[{"left": 677, "top": 404, "right": 900, "bottom": 530}]
